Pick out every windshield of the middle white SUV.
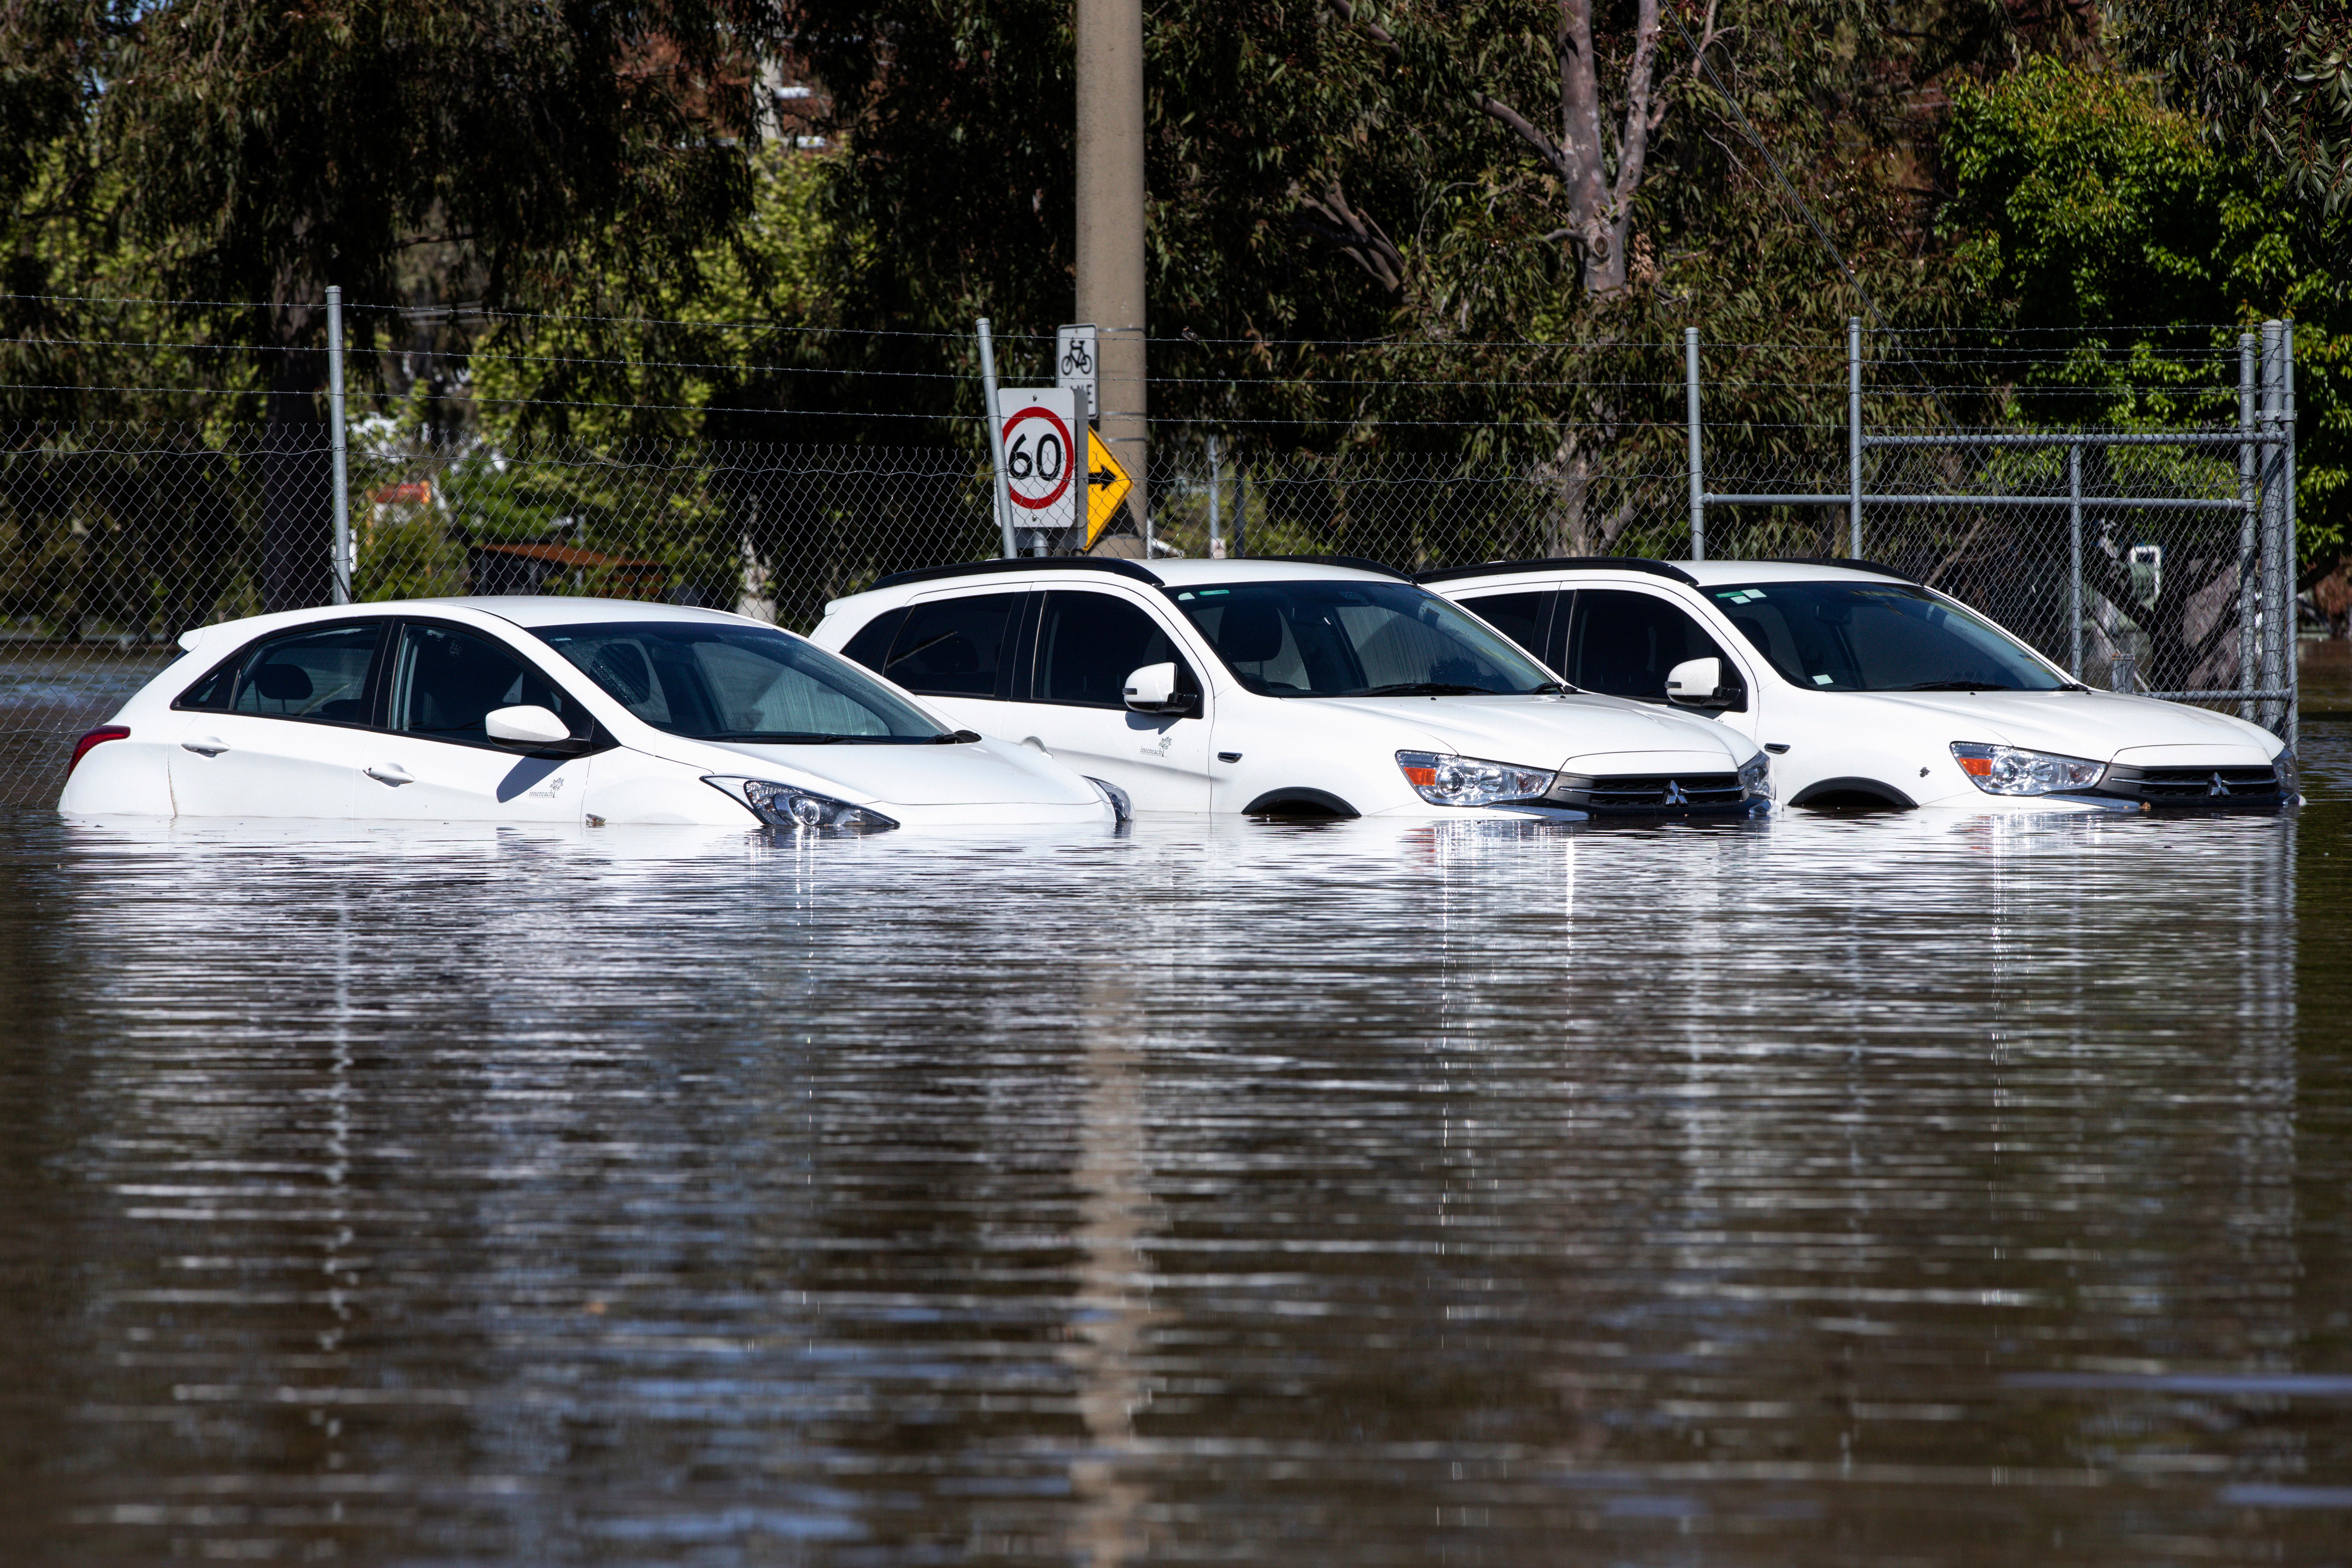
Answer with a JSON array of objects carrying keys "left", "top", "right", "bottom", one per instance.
[{"left": 1167, "top": 581, "right": 1559, "bottom": 696}]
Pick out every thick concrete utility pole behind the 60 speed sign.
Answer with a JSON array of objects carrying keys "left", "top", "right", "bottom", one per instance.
[{"left": 1073, "top": 0, "right": 1150, "bottom": 552}]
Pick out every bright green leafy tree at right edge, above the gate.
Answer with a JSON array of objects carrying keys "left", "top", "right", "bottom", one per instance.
[{"left": 1943, "top": 61, "right": 2352, "bottom": 559}]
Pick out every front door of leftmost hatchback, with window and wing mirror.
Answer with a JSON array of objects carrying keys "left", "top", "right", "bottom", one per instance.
[{"left": 355, "top": 621, "right": 597, "bottom": 823}]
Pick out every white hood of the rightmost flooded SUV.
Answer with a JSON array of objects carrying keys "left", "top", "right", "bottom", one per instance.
[{"left": 1856, "top": 691, "right": 2279, "bottom": 762}]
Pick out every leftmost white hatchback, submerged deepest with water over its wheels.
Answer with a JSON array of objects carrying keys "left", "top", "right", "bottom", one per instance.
[{"left": 56, "top": 597, "right": 1124, "bottom": 830}]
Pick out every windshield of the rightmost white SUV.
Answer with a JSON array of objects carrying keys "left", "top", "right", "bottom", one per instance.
[{"left": 1708, "top": 583, "right": 2072, "bottom": 691}]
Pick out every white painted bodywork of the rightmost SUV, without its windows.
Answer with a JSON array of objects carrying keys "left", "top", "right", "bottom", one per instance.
[{"left": 1430, "top": 562, "right": 2284, "bottom": 811}]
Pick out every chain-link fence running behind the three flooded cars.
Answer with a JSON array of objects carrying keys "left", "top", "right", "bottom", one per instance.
[{"left": 0, "top": 319, "right": 2293, "bottom": 804}]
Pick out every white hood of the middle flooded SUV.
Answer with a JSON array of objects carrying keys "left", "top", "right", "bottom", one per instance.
[{"left": 1310, "top": 693, "right": 1757, "bottom": 769}]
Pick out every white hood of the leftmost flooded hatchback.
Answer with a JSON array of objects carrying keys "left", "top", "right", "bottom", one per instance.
[{"left": 677, "top": 740, "right": 1101, "bottom": 806}]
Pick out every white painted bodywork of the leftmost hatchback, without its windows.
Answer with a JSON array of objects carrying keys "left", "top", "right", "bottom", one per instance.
[{"left": 59, "top": 597, "right": 1115, "bottom": 830}]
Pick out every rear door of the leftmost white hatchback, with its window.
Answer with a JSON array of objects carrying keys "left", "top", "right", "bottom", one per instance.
[{"left": 169, "top": 618, "right": 388, "bottom": 816}]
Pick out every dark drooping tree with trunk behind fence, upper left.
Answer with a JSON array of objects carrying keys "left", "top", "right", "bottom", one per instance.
[{"left": 0, "top": 0, "right": 774, "bottom": 604}]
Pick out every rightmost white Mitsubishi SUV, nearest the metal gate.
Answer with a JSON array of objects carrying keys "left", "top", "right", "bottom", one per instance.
[{"left": 1418, "top": 557, "right": 2296, "bottom": 811}]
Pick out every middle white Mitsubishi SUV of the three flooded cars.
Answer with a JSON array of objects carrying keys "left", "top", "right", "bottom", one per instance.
[{"left": 811, "top": 557, "right": 1769, "bottom": 820}]
